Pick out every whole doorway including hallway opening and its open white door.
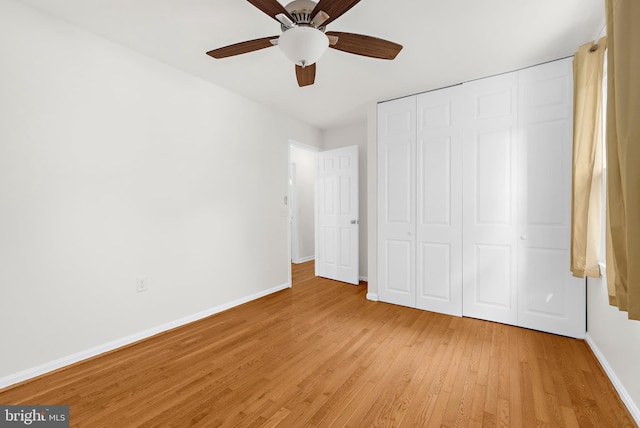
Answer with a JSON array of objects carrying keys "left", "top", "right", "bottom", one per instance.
[{"left": 288, "top": 142, "right": 360, "bottom": 285}]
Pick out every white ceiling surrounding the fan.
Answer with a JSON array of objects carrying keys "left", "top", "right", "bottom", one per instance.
[{"left": 20, "top": 0, "right": 604, "bottom": 129}]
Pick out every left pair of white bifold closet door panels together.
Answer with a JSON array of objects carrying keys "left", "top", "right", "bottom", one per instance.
[{"left": 378, "top": 86, "right": 462, "bottom": 316}]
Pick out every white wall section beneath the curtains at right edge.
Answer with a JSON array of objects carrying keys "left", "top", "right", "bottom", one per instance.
[{"left": 587, "top": 270, "right": 640, "bottom": 425}]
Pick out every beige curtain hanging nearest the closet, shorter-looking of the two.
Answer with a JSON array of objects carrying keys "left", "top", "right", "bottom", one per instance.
[{"left": 571, "top": 37, "right": 606, "bottom": 278}]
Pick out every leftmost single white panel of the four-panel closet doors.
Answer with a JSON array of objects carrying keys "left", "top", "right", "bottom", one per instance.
[{"left": 378, "top": 97, "right": 416, "bottom": 308}]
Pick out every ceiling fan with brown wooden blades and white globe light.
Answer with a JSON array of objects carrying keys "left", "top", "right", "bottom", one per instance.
[{"left": 207, "top": 0, "right": 402, "bottom": 87}]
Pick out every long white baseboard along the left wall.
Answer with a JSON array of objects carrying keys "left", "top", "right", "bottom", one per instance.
[{"left": 0, "top": 283, "right": 291, "bottom": 389}]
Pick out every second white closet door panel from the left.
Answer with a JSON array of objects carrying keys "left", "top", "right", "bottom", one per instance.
[{"left": 416, "top": 86, "right": 462, "bottom": 316}]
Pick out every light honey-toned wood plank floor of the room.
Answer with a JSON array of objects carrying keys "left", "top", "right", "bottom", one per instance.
[{"left": 0, "top": 262, "right": 636, "bottom": 428}]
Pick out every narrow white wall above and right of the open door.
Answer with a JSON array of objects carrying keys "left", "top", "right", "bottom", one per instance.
[{"left": 322, "top": 123, "right": 369, "bottom": 279}]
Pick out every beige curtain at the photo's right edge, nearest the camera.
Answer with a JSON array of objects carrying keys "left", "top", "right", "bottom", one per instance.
[{"left": 606, "top": 0, "right": 640, "bottom": 320}]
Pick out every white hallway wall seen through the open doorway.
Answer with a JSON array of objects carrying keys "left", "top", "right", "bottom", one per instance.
[{"left": 289, "top": 146, "right": 318, "bottom": 263}]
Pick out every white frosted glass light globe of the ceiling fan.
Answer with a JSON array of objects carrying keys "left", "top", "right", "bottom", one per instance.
[{"left": 278, "top": 27, "right": 329, "bottom": 67}]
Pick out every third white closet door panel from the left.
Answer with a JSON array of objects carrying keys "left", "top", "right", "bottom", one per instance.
[{"left": 463, "top": 73, "right": 518, "bottom": 325}]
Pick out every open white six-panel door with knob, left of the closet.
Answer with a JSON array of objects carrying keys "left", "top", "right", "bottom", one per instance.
[{"left": 315, "top": 146, "right": 360, "bottom": 285}]
